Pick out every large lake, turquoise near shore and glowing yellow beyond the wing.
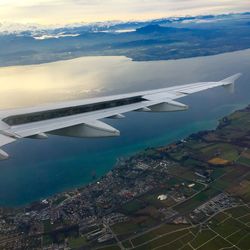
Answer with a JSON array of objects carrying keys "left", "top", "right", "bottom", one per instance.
[{"left": 0, "top": 50, "right": 250, "bottom": 206}]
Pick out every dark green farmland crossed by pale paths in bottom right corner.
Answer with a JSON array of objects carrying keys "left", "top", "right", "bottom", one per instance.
[{"left": 111, "top": 206, "right": 250, "bottom": 250}]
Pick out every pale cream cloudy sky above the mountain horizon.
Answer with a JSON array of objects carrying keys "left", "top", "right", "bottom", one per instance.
[{"left": 0, "top": 0, "right": 250, "bottom": 25}]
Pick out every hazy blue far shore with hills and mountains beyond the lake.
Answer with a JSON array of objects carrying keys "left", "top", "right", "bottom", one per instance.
[{"left": 0, "top": 13, "right": 250, "bottom": 66}]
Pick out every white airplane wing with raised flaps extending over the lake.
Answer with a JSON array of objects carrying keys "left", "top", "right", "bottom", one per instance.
[{"left": 0, "top": 73, "right": 241, "bottom": 160}]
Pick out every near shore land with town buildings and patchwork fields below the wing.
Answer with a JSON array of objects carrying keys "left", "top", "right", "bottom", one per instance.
[{"left": 0, "top": 106, "right": 250, "bottom": 250}]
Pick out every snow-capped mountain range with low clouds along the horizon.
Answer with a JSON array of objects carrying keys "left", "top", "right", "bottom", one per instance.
[{"left": 0, "top": 13, "right": 249, "bottom": 40}]
